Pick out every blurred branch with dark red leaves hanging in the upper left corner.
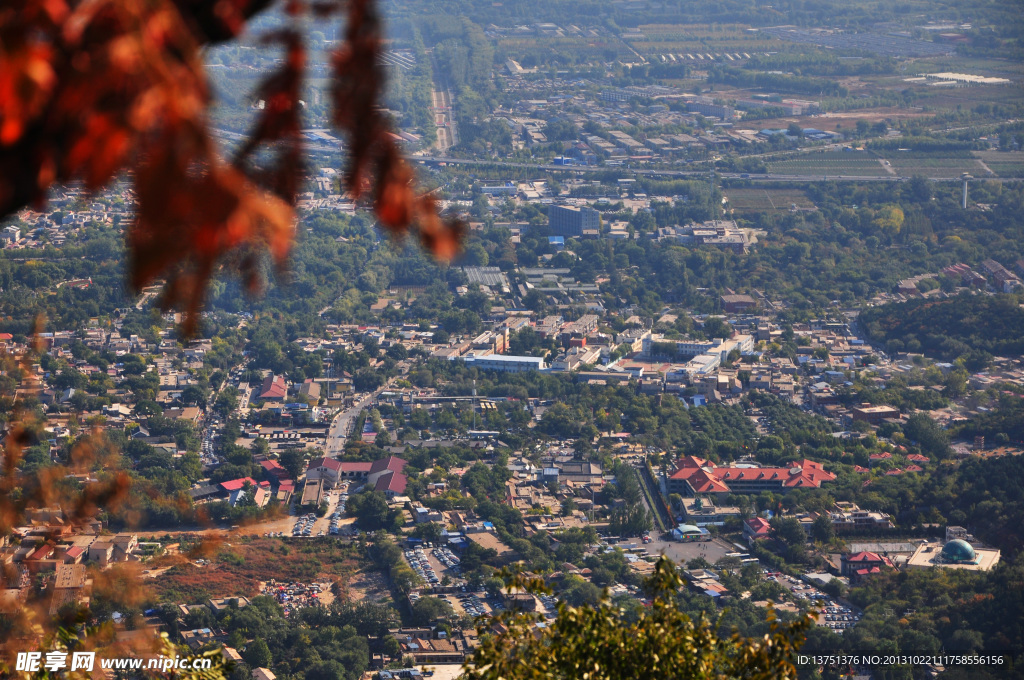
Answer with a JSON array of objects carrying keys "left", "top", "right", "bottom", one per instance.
[{"left": 0, "top": 0, "right": 462, "bottom": 334}]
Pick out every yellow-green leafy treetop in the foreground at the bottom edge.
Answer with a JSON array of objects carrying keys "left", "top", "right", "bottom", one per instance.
[{"left": 464, "top": 557, "right": 812, "bottom": 680}]
